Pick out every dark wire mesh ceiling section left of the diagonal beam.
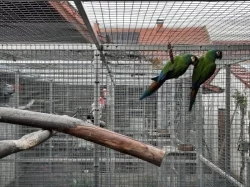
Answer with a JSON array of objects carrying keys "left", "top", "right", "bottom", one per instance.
[{"left": 0, "top": 1, "right": 91, "bottom": 43}]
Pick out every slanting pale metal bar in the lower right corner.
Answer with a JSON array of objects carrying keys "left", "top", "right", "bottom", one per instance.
[{"left": 199, "top": 155, "right": 244, "bottom": 187}]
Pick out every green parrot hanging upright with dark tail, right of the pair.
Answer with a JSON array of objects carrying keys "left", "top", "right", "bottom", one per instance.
[{"left": 189, "top": 50, "right": 222, "bottom": 111}]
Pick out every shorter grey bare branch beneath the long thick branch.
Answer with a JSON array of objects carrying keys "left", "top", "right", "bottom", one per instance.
[{"left": 0, "top": 130, "right": 53, "bottom": 158}]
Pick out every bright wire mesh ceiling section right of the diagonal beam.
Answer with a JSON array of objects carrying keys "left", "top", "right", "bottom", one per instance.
[{"left": 83, "top": 1, "right": 250, "bottom": 45}]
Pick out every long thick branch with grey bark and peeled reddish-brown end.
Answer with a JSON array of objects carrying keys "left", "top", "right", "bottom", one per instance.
[{"left": 0, "top": 107, "right": 165, "bottom": 166}]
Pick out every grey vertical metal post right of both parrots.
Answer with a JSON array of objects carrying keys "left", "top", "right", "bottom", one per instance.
[{"left": 225, "top": 65, "right": 231, "bottom": 174}]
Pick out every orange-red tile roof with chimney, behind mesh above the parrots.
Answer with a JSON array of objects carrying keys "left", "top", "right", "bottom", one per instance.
[{"left": 95, "top": 24, "right": 211, "bottom": 68}]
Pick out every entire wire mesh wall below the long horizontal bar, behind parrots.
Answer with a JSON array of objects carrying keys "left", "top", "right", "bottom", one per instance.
[{"left": 1, "top": 46, "right": 249, "bottom": 186}]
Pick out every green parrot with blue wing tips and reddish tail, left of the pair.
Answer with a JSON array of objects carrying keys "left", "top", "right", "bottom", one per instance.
[{"left": 140, "top": 54, "right": 198, "bottom": 100}]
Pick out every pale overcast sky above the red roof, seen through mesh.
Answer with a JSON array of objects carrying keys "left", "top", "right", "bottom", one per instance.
[{"left": 69, "top": 1, "right": 250, "bottom": 40}]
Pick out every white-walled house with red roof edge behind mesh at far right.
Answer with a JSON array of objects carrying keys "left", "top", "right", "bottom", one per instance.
[{"left": 202, "top": 62, "right": 250, "bottom": 180}]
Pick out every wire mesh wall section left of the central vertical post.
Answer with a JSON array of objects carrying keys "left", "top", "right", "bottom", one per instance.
[{"left": 1, "top": 46, "right": 99, "bottom": 186}]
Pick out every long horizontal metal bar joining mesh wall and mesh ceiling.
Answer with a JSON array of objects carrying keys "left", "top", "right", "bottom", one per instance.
[{"left": 0, "top": 43, "right": 250, "bottom": 51}]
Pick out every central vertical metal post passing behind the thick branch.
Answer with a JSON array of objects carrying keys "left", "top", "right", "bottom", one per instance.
[{"left": 94, "top": 50, "right": 100, "bottom": 187}]
